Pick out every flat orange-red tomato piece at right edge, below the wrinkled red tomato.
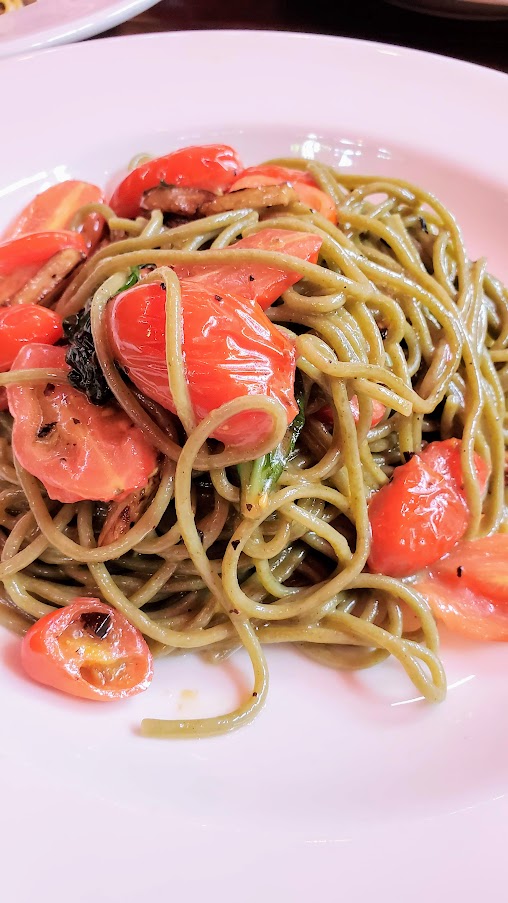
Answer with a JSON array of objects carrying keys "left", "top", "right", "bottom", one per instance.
[{"left": 415, "top": 533, "right": 508, "bottom": 640}]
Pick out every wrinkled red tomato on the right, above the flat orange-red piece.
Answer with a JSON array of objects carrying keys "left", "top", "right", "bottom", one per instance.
[{"left": 368, "top": 455, "right": 468, "bottom": 577}]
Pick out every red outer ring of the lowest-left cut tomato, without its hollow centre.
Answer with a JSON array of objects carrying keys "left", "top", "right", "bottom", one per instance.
[{"left": 21, "top": 597, "right": 153, "bottom": 702}]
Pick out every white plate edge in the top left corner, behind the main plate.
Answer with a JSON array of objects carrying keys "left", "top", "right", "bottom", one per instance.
[{"left": 0, "top": 0, "right": 157, "bottom": 58}]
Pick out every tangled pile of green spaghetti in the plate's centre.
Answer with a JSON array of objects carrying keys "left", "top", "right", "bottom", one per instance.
[{"left": 0, "top": 160, "right": 508, "bottom": 736}]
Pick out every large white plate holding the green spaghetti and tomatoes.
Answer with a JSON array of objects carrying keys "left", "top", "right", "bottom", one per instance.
[{"left": 0, "top": 32, "right": 508, "bottom": 903}]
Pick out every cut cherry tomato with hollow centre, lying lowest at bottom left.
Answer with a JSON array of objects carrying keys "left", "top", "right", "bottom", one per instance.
[{"left": 21, "top": 598, "right": 153, "bottom": 702}]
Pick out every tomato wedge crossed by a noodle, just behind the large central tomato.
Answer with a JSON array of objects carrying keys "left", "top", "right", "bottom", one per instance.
[{"left": 174, "top": 229, "right": 323, "bottom": 310}]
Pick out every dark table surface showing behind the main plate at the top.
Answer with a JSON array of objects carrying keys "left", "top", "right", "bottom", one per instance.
[{"left": 107, "top": 0, "right": 508, "bottom": 72}]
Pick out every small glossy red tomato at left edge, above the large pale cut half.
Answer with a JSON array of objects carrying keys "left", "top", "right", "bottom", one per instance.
[{"left": 0, "top": 304, "right": 63, "bottom": 373}]
